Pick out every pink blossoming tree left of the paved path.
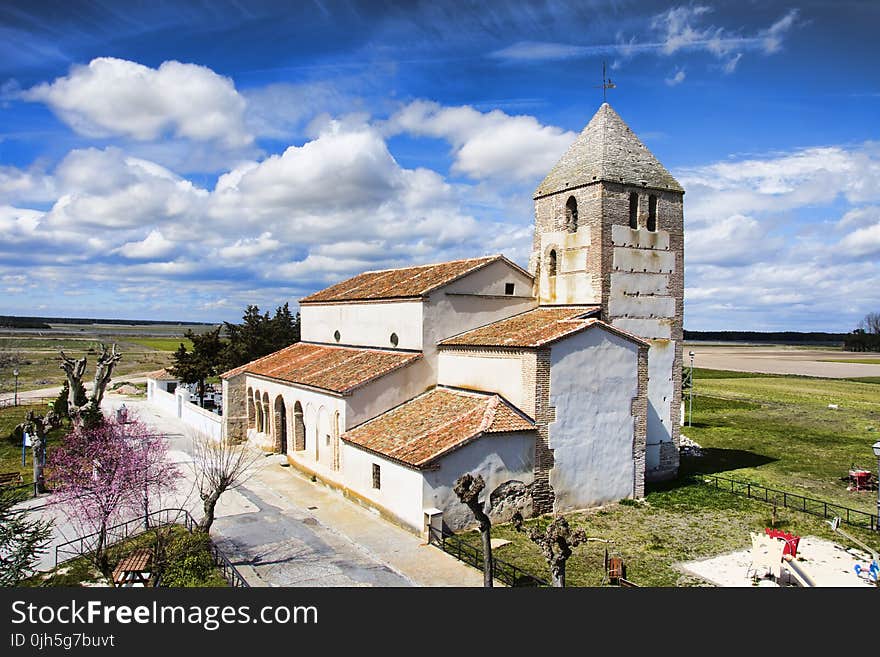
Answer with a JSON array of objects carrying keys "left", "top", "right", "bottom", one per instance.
[{"left": 46, "top": 415, "right": 180, "bottom": 574}]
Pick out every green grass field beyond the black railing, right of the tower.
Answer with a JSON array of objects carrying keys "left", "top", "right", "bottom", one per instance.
[{"left": 682, "top": 370, "right": 880, "bottom": 512}]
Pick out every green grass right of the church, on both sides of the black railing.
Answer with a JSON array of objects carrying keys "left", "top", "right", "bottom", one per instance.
[{"left": 462, "top": 370, "right": 880, "bottom": 586}]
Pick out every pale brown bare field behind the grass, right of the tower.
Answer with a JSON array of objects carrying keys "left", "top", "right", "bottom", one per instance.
[{"left": 684, "top": 342, "right": 880, "bottom": 379}]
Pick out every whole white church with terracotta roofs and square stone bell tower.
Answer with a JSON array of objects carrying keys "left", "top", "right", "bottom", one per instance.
[{"left": 222, "top": 103, "right": 684, "bottom": 532}]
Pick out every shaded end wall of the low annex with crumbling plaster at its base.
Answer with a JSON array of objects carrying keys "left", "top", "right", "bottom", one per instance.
[{"left": 424, "top": 431, "right": 535, "bottom": 530}]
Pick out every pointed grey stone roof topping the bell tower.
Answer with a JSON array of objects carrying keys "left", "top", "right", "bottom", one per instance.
[{"left": 535, "top": 103, "right": 684, "bottom": 198}]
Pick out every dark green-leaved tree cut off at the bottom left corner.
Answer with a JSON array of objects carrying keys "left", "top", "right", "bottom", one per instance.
[{"left": 0, "top": 486, "right": 52, "bottom": 586}]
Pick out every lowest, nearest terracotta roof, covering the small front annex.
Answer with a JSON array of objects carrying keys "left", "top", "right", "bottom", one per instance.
[{"left": 342, "top": 388, "right": 535, "bottom": 468}]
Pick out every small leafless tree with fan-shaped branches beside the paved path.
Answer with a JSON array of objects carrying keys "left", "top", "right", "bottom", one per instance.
[{"left": 192, "top": 434, "right": 261, "bottom": 533}]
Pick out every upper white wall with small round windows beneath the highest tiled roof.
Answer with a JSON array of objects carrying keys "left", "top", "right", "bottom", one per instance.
[{"left": 300, "top": 300, "right": 422, "bottom": 350}]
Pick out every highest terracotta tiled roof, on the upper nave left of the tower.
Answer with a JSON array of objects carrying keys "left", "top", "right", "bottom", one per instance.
[{"left": 300, "top": 255, "right": 516, "bottom": 303}]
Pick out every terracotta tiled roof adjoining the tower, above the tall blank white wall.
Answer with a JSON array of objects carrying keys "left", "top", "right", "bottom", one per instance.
[{"left": 440, "top": 306, "right": 599, "bottom": 347}]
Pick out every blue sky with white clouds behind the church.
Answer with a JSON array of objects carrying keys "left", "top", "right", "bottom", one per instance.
[{"left": 0, "top": 0, "right": 880, "bottom": 331}]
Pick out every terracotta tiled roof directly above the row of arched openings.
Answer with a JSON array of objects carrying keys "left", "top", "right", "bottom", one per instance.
[{"left": 220, "top": 342, "right": 422, "bottom": 393}]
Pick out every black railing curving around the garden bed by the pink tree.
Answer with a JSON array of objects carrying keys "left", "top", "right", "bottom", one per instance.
[{"left": 55, "top": 509, "right": 250, "bottom": 588}]
